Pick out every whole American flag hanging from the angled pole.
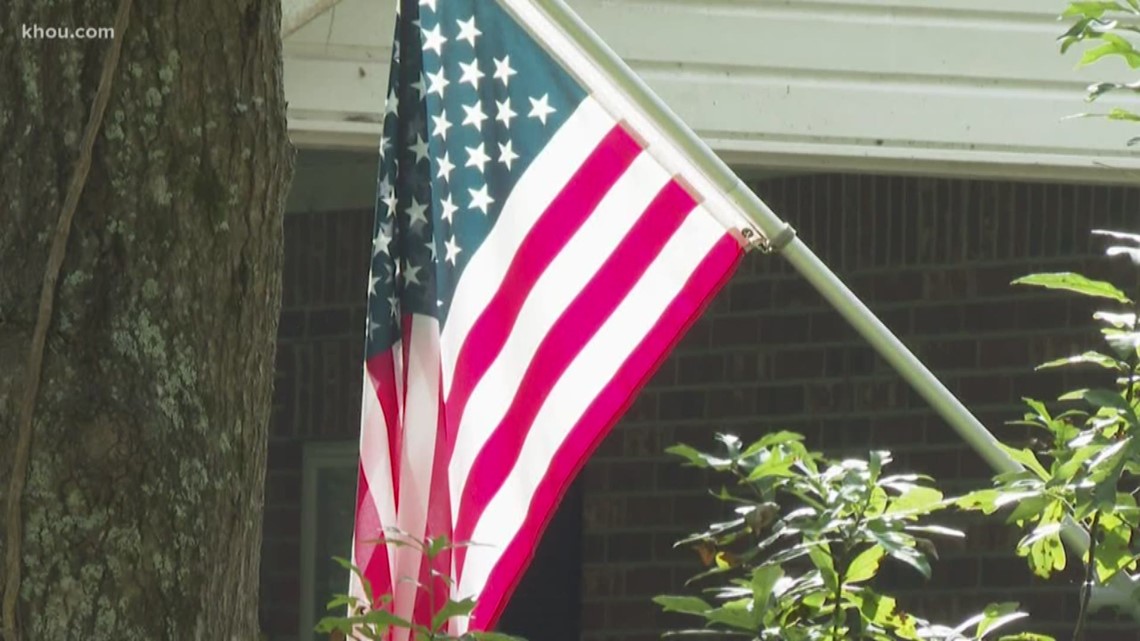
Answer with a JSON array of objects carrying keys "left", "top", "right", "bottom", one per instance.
[{"left": 352, "top": 0, "right": 743, "bottom": 629}]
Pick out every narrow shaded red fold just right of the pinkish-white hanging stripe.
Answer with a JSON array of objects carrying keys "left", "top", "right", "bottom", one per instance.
[{"left": 413, "top": 372, "right": 455, "bottom": 630}]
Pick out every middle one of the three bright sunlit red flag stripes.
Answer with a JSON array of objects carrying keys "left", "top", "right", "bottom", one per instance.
[{"left": 455, "top": 181, "right": 697, "bottom": 576}]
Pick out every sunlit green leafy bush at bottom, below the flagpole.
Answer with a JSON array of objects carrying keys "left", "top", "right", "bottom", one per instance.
[{"left": 654, "top": 432, "right": 1049, "bottom": 641}]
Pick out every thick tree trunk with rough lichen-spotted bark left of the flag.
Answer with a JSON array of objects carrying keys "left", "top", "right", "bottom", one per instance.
[{"left": 0, "top": 0, "right": 293, "bottom": 641}]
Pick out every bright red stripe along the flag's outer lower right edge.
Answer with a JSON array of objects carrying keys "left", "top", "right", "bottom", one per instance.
[{"left": 471, "top": 235, "right": 742, "bottom": 631}]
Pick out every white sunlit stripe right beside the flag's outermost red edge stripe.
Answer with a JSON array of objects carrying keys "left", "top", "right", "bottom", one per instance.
[{"left": 458, "top": 208, "right": 725, "bottom": 597}]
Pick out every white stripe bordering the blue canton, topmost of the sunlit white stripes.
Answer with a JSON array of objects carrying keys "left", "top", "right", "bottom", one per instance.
[{"left": 440, "top": 97, "right": 616, "bottom": 397}]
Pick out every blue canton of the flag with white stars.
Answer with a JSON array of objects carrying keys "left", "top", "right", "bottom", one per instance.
[{"left": 367, "top": 0, "right": 586, "bottom": 355}]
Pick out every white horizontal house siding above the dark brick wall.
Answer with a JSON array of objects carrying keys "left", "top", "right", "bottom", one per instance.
[{"left": 285, "top": 0, "right": 1140, "bottom": 181}]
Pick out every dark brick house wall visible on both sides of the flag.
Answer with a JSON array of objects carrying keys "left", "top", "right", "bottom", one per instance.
[{"left": 261, "top": 173, "right": 1140, "bottom": 641}]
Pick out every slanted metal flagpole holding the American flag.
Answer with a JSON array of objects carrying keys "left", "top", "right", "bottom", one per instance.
[{"left": 534, "top": 0, "right": 1140, "bottom": 619}]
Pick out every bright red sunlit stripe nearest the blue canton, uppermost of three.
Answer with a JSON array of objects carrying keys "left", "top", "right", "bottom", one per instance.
[{"left": 447, "top": 127, "right": 641, "bottom": 452}]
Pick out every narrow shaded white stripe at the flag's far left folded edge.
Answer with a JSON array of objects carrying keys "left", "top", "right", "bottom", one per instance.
[{"left": 352, "top": 364, "right": 400, "bottom": 598}]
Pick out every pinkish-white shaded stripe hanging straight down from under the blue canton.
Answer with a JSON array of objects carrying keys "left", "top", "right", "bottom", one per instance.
[{"left": 389, "top": 315, "right": 439, "bottom": 641}]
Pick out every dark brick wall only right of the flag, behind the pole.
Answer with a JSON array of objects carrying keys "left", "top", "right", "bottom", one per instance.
[{"left": 583, "top": 175, "right": 1140, "bottom": 641}]
